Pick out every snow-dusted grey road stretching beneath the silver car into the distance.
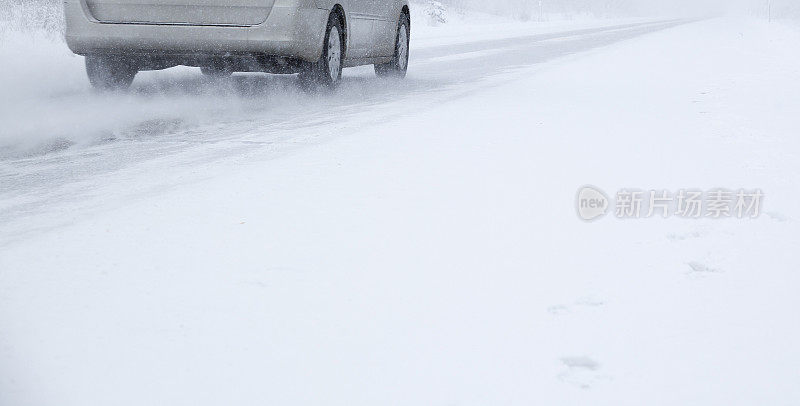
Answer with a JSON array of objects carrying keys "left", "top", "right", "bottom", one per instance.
[{"left": 0, "top": 21, "right": 682, "bottom": 246}]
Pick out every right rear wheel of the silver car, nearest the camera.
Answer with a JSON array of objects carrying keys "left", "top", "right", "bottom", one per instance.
[{"left": 299, "top": 13, "right": 345, "bottom": 89}]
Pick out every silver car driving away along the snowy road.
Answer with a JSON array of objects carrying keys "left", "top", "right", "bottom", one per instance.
[{"left": 64, "top": 0, "right": 411, "bottom": 89}]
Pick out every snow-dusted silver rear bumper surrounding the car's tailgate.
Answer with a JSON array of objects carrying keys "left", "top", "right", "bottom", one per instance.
[{"left": 64, "top": 0, "right": 330, "bottom": 62}]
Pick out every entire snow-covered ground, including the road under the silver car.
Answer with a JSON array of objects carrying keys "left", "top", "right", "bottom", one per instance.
[{"left": 0, "top": 9, "right": 800, "bottom": 406}]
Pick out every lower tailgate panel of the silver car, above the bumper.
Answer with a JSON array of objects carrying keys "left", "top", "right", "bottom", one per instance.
[{"left": 85, "top": 0, "right": 275, "bottom": 26}]
